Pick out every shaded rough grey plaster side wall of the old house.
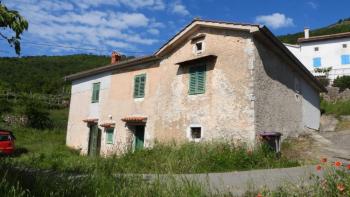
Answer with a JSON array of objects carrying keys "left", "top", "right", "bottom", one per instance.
[{"left": 254, "top": 42, "right": 303, "bottom": 137}]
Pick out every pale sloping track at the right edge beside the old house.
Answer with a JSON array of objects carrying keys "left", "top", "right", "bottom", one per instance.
[{"left": 311, "top": 130, "right": 350, "bottom": 164}]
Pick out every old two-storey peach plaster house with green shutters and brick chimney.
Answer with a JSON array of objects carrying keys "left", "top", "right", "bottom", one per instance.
[{"left": 66, "top": 20, "right": 325, "bottom": 155}]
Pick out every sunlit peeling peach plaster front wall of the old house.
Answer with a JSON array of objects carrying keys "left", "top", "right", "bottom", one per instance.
[{"left": 67, "top": 28, "right": 264, "bottom": 155}]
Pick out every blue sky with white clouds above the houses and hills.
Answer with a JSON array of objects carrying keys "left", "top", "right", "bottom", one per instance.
[{"left": 0, "top": 0, "right": 350, "bottom": 56}]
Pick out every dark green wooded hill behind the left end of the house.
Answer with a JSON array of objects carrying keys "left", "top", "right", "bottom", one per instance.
[{"left": 0, "top": 54, "right": 131, "bottom": 94}]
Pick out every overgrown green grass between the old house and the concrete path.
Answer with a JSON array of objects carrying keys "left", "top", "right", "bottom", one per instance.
[{"left": 2, "top": 128, "right": 299, "bottom": 173}]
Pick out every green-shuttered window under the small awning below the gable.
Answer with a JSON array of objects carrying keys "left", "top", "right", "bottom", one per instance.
[{"left": 188, "top": 65, "right": 206, "bottom": 95}]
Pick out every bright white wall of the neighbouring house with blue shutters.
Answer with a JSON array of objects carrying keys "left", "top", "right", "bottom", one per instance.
[{"left": 285, "top": 38, "right": 350, "bottom": 81}]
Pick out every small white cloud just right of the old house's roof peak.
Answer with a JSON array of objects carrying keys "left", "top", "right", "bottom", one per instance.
[{"left": 255, "top": 13, "right": 294, "bottom": 29}]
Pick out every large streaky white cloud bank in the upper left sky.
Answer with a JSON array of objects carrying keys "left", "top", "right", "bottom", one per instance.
[{"left": 5, "top": 0, "right": 165, "bottom": 52}]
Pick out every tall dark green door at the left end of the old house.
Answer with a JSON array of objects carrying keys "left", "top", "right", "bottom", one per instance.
[{"left": 88, "top": 124, "right": 101, "bottom": 156}]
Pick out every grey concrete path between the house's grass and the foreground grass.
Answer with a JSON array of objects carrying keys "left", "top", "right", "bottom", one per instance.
[{"left": 143, "top": 166, "right": 322, "bottom": 196}]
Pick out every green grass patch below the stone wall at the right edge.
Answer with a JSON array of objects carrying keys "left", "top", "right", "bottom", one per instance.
[{"left": 320, "top": 99, "right": 350, "bottom": 116}]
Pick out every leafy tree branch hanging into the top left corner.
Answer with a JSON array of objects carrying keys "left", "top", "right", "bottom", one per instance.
[{"left": 0, "top": 1, "right": 28, "bottom": 55}]
